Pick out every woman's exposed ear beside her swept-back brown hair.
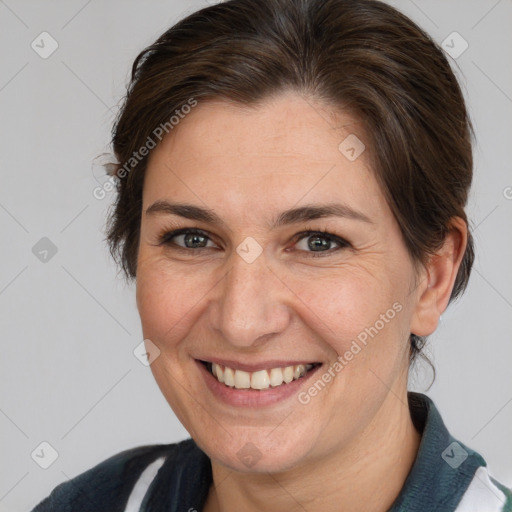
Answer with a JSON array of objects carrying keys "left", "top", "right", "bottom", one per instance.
[{"left": 411, "top": 217, "right": 468, "bottom": 336}]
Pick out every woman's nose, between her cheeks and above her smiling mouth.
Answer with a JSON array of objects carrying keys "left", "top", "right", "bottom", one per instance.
[{"left": 210, "top": 247, "right": 291, "bottom": 347}]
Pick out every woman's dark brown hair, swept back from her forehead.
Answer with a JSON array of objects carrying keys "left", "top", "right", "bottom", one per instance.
[{"left": 107, "top": 0, "right": 474, "bottom": 362}]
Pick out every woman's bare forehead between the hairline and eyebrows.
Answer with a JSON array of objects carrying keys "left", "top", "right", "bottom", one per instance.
[{"left": 144, "top": 94, "right": 385, "bottom": 224}]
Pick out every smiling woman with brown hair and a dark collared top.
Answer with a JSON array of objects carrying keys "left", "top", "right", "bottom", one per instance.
[{"left": 34, "top": 0, "right": 512, "bottom": 512}]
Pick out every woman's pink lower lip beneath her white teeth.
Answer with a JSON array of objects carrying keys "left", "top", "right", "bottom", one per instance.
[{"left": 196, "top": 360, "right": 323, "bottom": 407}]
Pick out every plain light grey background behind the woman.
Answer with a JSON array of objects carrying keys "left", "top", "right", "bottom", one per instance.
[{"left": 0, "top": 0, "right": 512, "bottom": 512}]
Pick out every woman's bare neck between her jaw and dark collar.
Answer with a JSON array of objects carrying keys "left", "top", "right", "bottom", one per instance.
[{"left": 204, "top": 390, "right": 421, "bottom": 512}]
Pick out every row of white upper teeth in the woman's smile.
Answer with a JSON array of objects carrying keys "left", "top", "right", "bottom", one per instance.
[{"left": 211, "top": 363, "right": 313, "bottom": 389}]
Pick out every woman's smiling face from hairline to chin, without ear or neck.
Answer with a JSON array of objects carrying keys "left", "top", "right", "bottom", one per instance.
[{"left": 137, "top": 93, "right": 419, "bottom": 472}]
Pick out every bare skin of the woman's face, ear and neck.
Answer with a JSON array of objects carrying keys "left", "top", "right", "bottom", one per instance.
[{"left": 137, "top": 92, "right": 467, "bottom": 512}]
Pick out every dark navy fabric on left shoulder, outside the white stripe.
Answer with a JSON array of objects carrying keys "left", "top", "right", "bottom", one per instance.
[{"left": 32, "top": 439, "right": 196, "bottom": 512}]
